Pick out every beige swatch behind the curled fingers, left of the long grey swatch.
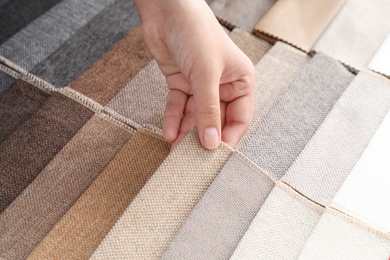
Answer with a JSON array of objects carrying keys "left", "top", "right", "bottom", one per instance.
[{"left": 237, "top": 42, "right": 309, "bottom": 151}]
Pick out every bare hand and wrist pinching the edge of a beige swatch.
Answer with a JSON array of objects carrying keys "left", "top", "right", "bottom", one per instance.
[{"left": 134, "top": 0, "right": 255, "bottom": 149}]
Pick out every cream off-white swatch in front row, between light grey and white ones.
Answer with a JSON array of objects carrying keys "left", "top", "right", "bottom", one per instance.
[{"left": 231, "top": 185, "right": 323, "bottom": 259}]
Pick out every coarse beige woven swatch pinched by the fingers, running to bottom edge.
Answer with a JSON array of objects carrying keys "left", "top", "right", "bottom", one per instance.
[{"left": 92, "top": 132, "right": 232, "bottom": 259}]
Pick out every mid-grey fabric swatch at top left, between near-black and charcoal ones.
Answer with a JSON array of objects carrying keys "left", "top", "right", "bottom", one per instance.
[{"left": 0, "top": 0, "right": 114, "bottom": 71}]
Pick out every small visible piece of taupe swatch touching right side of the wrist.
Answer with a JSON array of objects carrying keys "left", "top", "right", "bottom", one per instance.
[{"left": 229, "top": 28, "right": 271, "bottom": 65}]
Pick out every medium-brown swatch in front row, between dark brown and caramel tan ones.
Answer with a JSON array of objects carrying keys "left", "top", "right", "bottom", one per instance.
[{"left": 0, "top": 116, "right": 131, "bottom": 259}]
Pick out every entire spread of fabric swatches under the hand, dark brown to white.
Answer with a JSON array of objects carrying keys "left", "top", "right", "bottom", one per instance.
[{"left": 0, "top": 0, "right": 390, "bottom": 260}]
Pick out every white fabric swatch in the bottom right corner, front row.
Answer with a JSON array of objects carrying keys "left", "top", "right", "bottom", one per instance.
[{"left": 298, "top": 210, "right": 390, "bottom": 260}]
